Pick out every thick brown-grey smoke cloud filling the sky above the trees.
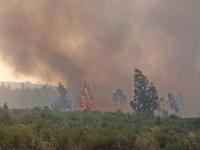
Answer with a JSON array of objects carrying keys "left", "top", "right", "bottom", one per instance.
[{"left": 0, "top": 0, "right": 200, "bottom": 115}]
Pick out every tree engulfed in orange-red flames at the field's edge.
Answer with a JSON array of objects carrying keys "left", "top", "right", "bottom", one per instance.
[{"left": 80, "top": 82, "right": 94, "bottom": 112}]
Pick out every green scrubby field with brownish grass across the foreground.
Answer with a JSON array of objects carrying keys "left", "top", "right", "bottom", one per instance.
[{"left": 0, "top": 108, "right": 200, "bottom": 150}]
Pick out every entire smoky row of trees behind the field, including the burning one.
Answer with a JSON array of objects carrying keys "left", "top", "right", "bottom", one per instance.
[{"left": 0, "top": 69, "right": 183, "bottom": 116}]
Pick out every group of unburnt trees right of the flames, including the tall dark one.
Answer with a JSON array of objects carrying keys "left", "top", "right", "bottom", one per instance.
[{"left": 112, "top": 69, "right": 183, "bottom": 116}]
